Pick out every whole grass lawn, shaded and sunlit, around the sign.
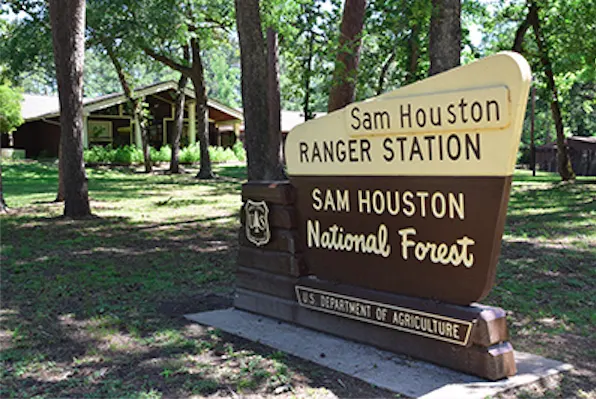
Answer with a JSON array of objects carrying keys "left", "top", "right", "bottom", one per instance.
[{"left": 0, "top": 162, "right": 596, "bottom": 398}]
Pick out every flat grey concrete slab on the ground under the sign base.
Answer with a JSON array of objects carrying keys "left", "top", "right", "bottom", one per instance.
[{"left": 186, "top": 309, "right": 572, "bottom": 399}]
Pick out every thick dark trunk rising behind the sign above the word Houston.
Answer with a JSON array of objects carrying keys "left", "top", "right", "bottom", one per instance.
[{"left": 428, "top": 0, "right": 461, "bottom": 76}]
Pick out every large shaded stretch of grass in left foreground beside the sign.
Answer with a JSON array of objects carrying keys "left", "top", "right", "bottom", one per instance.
[{"left": 0, "top": 205, "right": 382, "bottom": 398}]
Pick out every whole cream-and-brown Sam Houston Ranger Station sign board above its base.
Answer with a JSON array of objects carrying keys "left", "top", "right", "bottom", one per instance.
[{"left": 285, "top": 53, "right": 531, "bottom": 304}]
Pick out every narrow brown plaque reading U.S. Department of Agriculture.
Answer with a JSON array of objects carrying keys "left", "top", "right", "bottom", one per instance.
[{"left": 296, "top": 285, "right": 472, "bottom": 346}]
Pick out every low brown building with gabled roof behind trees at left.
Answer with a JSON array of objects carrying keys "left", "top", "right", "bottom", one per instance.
[{"left": 9, "top": 81, "right": 243, "bottom": 158}]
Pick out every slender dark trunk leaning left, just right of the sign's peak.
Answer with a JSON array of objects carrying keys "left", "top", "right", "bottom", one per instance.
[{"left": 528, "top": 2, "right": 575, "bottom": 181}]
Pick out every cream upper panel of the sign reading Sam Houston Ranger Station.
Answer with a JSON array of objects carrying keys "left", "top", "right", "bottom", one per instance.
[{"left": 286, "top": 52, "right": 531, "bottom": 176}]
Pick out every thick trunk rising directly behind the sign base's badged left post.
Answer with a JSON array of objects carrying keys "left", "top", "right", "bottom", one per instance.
[{"left": 234, "top": 0, "right": 284, "bottom": 180}]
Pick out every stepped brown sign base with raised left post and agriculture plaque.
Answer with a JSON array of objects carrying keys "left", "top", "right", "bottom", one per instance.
[{"left": 234, "top": 182, "right": 516, "bottom": 380}]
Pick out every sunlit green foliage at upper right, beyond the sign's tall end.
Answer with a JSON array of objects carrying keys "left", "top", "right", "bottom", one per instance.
[{"left": 479, "top": 0, "right": 596, "bottom": 147}]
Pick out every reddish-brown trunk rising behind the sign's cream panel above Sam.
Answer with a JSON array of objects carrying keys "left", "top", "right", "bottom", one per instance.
[{"left": 327, "top": 0, "right": 366, "bottom": 112}]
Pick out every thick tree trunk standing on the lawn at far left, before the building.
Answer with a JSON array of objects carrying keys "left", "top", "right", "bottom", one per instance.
[{"left": 50, "top": 0, "right": 91, "bottom": 218}]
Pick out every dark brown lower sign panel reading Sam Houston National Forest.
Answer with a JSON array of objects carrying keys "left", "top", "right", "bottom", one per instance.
[{"left": 292, "top": 176, "right": 511, "bottom": 304}]
